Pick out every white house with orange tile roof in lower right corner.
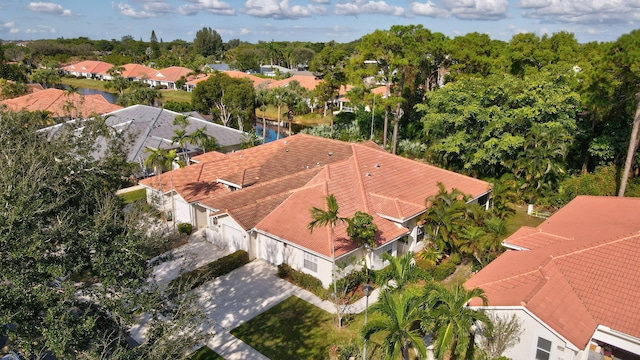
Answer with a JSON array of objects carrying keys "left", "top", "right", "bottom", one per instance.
[{"left": 465, "top": 196, "right": 640, "bottom": 360}]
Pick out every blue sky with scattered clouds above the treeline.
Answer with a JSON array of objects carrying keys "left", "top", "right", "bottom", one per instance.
[{"left": 0, "top": 0, "right": 640, "bottom": 43}]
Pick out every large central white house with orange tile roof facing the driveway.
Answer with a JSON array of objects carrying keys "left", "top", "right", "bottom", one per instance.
[{"left": 140, "top": 134, "right": 490, "bottom": 286}]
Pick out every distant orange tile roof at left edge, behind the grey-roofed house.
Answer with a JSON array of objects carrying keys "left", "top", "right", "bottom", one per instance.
[{"left": 1, "top": 89, "right": 122, "bottom": 118}]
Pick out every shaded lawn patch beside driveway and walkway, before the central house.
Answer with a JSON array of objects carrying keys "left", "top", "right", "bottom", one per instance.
[{"left": 231, "top": 296, "right": 372, "bottom": 359}]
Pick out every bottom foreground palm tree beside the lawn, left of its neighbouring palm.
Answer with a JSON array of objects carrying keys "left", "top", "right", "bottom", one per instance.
[{"left": 362, "top": 291, "right": 427, "bottom": 360}]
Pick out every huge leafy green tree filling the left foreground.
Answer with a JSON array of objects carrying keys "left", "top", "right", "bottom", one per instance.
[{"left": 0, "top": 112, "right": 199, "bottom": 358}]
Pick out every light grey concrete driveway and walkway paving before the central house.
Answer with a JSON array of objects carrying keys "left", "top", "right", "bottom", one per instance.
[{"left": 139, "top": 233, "right": 380, "bottom": 360}]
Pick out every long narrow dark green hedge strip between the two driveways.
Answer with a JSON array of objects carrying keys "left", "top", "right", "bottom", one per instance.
[{"left": 169, "top": 250, "right": 249, "bottom": 292}]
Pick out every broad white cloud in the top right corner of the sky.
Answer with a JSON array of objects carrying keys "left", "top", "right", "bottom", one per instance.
[{"left": 518, "top": 0, "right": 640, "bottom": 25}]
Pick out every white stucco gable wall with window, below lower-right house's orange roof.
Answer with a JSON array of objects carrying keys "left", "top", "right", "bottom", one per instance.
[{"left": 478, "top": 307, "right": 586, "bottom": 360}]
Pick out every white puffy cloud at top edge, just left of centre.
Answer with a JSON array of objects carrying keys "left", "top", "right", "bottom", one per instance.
[{"left": 240, "top": 0, "right": 327, "bottom": 20}]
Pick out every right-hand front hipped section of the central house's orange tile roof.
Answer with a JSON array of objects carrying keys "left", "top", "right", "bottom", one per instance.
[{"left": 256, "top": 143, "right": 489, "bottom": 257}]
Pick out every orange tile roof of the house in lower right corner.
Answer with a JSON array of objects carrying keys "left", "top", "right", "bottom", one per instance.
[{"left": 465, "top": 196, "right": 640, "bottom": 348}]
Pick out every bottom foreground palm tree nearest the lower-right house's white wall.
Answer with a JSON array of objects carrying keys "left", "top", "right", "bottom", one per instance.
[{"left": 423, "top": 283, "right": 493, "bottom": 359}]
